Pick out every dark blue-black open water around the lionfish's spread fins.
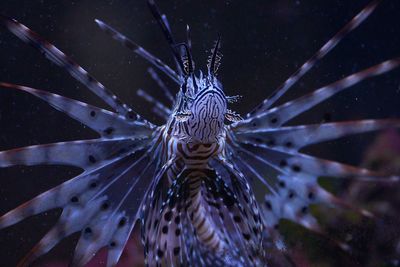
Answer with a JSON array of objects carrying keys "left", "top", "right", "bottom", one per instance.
[{"left": 0, "top": 0, "right": 400, "bottom": 267}]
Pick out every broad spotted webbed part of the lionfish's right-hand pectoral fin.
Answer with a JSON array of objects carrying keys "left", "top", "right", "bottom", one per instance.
[{"left": 228, "top": 124, "right": 399, "bottom": 254}]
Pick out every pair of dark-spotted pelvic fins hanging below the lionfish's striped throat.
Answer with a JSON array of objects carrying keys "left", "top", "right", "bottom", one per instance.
[{"left": 142, "top": 170, "right": 261, "bottom": 266}]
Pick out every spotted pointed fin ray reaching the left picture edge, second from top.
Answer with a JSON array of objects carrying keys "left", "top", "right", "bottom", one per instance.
[{"left": 0, "top": 82, "right": 155, "bottom": 139}]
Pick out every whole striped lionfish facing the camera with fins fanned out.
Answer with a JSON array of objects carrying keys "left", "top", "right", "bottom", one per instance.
[{"left": 0, "top": 0, "right": 400, "bottom": 266}]
